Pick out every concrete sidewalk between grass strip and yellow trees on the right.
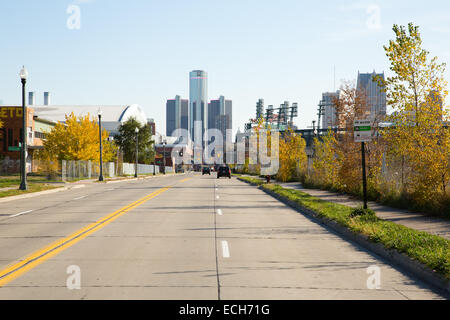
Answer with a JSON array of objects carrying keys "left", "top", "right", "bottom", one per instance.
[{"left": 241, "top": 176, "right": 450, "bottom": 240}]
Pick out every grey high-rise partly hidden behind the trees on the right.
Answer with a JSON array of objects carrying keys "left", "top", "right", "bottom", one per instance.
[{"left": 356, "top": 70, "right": 386, "bottom": 119}]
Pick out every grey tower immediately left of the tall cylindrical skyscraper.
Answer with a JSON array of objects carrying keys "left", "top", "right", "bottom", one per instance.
[{"left": 166, "top": 95, "right": 189, "bottom": 136}]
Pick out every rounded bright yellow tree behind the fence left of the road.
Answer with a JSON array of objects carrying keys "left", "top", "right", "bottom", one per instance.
[{"left": 41, "top": 113, "right": 116, "bottom": 162}]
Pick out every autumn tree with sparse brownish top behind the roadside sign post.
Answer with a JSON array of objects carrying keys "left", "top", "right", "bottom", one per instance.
[{"left": 312, "top": 83, "right": 382, "bottom": 194}]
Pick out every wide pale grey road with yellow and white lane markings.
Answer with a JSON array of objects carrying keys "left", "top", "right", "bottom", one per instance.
[{"left": 0, "top": 173, "right": 442, "bottom": 299}]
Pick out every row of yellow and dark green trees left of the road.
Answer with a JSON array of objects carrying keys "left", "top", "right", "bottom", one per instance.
[{"left": 39, "top": 113, "right": 154, "bottom": 164}]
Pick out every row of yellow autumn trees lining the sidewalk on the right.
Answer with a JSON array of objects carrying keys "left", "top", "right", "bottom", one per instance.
[{"left": 253, "top": 24, "right": 450, "bottom": 216}]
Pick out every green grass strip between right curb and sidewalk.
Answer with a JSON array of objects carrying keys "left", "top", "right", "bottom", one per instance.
[{"left": 238, "top": 176, "right": 450, "bottom": 279}]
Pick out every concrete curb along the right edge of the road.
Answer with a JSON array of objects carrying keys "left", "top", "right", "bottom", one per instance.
[{"left": 238, "top": 178, "right": 450, "bottom": 299}]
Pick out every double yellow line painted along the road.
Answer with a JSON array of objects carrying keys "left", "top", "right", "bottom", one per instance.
[{"left": 0, "top": 185, "right": 171, "bottom": 287}]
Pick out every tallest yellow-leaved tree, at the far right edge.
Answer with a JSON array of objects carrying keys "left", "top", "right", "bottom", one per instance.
[{"left": 379, "top": 23, "right": 450, "bottom": 206}]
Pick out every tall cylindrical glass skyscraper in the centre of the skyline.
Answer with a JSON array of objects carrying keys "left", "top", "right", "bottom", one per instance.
[{"left": 189, "top": 70, "right": 208, "bottom": 140}]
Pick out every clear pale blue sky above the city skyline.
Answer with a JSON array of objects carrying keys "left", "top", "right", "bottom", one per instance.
[{"left": 0, "top": 0, "right": 450, "bottom": 132}]
